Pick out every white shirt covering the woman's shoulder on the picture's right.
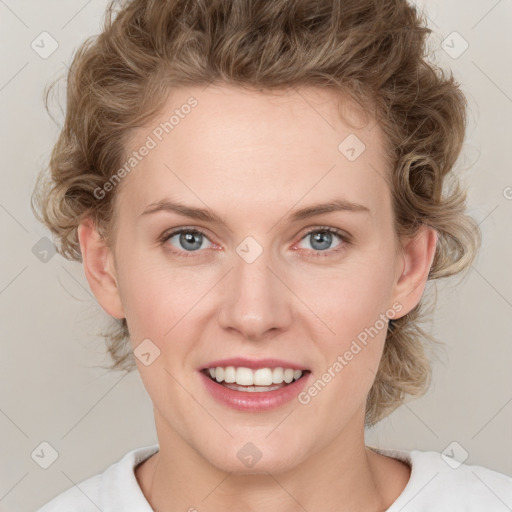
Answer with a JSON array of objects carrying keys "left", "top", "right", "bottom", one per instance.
[{"left": 371, "top": 447, "right": 512, "bottom": 512}]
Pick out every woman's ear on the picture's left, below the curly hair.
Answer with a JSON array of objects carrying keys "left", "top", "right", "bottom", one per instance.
[{"left": 78, "top": 219, "right": 125, "bottom": 319}]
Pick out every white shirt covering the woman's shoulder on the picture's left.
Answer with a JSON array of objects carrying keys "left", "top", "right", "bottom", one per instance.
[{"left": 36, "top": 445, "right": 158, "bottom": 512}]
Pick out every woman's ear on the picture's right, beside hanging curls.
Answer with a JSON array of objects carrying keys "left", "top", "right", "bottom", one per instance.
[{"left": 393, "top": 225, "right": 437, "bottom": 318}]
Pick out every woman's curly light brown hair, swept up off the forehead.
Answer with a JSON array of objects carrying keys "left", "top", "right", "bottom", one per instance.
[{"left": 31, "top": 0, "right": 481, "bottom": 426}]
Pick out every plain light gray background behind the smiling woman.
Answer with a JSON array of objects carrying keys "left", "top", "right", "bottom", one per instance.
[{"left": 0, "top": 0, "right": 512, "bottom": 512}]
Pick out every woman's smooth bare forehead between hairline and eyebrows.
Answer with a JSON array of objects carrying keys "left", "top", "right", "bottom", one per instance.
[{"left": 118, "top": 85, "right": 388, "bottom": 222}]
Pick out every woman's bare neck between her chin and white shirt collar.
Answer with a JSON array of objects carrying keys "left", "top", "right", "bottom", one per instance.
[{"left": 136, "top": 408, "right": 410, "bottom": 512}]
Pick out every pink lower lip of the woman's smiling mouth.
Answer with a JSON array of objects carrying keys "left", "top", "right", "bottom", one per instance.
[{"left": 199, "top": 371, "right": 311, "bottom": 412}]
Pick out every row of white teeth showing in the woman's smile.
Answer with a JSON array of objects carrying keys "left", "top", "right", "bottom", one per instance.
[{"left": 208, "top": 366, "right": 302, "bottom": 386}]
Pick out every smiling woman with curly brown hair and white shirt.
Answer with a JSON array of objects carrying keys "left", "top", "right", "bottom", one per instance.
[{"left": 31, "top": 0, "right": 512, "bottom": 512}]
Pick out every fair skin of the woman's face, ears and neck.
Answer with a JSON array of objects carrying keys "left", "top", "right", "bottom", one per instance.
[{"left": 79, "top": 85, "right": 436, "bottom": 512}]
